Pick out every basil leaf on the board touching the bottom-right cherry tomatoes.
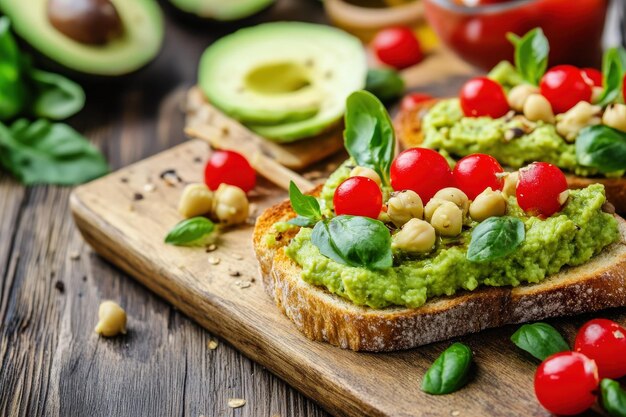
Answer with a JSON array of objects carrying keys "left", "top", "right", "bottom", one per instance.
[{"left": 511, "top": 323, "right": 570, "bottom": 361}]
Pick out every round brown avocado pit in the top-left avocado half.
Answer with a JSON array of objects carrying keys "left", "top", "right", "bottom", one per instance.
[{"left": 46, "top": 0, "right": 124, "bottom": 45}]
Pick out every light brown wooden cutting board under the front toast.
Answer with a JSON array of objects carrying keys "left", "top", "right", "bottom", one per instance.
[{"left": 71, "top": 141, "right": 626, "bottom": 417}]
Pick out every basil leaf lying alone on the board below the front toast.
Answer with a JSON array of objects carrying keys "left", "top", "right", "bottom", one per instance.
[{"left": 422, "top": 343, "right": 472, "bottom": 395}]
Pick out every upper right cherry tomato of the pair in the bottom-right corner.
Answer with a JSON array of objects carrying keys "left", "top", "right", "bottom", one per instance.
[{"left": 574, "top": 319, "right": 626, "bottom": 379}]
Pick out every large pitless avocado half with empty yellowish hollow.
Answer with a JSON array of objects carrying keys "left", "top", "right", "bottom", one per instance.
[{"left": 199, "top": 22, "right": 367, "bottom": 142}]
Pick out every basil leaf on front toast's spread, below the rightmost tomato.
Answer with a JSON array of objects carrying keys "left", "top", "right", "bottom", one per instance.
[{"left": 467, "top": 216, "right": 526, "bottom": 262}]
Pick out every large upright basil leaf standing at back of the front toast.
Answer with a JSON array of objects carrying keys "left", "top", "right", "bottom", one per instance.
[{"left": 344, "top": 91, "right": 396, "bottom": 185}]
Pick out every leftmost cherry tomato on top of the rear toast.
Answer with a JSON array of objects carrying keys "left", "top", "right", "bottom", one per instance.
[{"left": 460, "top": 77, "right": 509, "bottom": 119}]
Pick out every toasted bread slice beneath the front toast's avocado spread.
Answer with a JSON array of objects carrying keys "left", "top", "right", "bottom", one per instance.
[{"left": 254, "top": 187, "right": 626, "bottom": 352}]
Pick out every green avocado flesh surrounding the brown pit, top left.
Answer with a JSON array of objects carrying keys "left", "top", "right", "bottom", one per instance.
[{"left": 0, "top": 0, "right": 164, "bottom": 76}]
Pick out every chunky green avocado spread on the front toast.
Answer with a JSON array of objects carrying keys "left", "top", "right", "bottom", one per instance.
[{"left": 284, "top": 185, "right": 620, "bottom": 308}]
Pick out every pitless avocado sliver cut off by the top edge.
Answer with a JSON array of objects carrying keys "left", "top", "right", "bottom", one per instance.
[{"left": 170, "top": 0, "right": 276, "bottom": 21}]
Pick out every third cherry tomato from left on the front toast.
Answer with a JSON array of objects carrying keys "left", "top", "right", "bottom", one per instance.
[{"left": 452, "top": 153, "right": 504, "bottom": 200}]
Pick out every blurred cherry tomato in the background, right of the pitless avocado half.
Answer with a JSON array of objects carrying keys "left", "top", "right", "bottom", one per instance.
[{"left": 372, "top": 26, "right": 424, "bottom": 69}]
